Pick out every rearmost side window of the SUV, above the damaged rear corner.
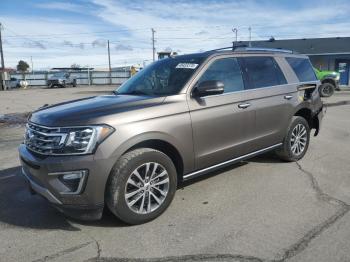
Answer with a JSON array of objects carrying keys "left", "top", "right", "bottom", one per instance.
[{"left": 286, "top": 57, "right": 317, "bottom": 82}]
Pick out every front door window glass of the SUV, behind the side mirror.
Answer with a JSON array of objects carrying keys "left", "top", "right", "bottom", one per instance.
[{"left": 199, "top": 58, "right": 244, "bottom": 93}]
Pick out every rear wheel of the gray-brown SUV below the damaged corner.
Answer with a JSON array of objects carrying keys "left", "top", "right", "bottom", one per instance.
[{"left": 276, "top": 116, "right": 310, "bottom": 162}]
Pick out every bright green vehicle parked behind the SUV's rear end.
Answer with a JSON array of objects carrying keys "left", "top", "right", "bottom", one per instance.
[{"left": 314, "top": 68, "right": 340, "bottom": 97}]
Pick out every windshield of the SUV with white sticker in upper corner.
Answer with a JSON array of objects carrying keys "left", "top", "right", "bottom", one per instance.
[{"left": 115, "top": 57, "right": 203, "bottom": 96}]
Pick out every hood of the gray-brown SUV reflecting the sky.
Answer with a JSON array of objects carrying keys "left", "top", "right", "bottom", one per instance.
[{"left": 29, "top": 95, "right": 165, "bottom": 126}]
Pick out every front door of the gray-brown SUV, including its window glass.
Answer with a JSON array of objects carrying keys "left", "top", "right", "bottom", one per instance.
[{"left": 188, "top": 57, "right": 255, "bottom": 169}]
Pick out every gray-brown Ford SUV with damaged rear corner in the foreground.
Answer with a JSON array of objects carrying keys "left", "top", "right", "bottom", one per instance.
[{"left": 19, "top": 48, "right": 323, "bottom": 224}]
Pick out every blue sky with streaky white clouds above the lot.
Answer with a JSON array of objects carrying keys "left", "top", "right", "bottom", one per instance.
[{"left": 0, "top": 0, "right": 350, "bottom": 70}]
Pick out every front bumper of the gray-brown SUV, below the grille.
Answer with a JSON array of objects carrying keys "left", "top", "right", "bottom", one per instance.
[{"left": 19, "top": 144, "right": 114, "bottom": 220}]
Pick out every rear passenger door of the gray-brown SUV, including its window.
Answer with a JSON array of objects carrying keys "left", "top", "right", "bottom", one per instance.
[{"left": 240, "top": 55, "right": 297, "bottom": 150}]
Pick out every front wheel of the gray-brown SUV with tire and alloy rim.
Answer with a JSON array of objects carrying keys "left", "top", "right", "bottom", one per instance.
[{"left": 106, "top": 148, "right": 177, "bottom": 225}]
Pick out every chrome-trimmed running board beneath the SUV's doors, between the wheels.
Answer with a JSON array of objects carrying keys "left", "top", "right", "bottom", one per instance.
[{"left": 183, "top": 143, "right": 282, "bottom": 181}]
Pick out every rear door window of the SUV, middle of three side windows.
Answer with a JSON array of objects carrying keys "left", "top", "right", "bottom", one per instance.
[{"left": 241, "top": 56, "right": 287, "bottom": 89}]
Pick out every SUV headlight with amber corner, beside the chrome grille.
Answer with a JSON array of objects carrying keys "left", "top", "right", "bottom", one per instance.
[{"left": 61, "top": 126, "right": 114, "bottom": 154}]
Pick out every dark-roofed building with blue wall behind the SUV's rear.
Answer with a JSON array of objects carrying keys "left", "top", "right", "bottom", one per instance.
[{"left": 240, "top": 37, "right": 350, "bottom": 86}]
